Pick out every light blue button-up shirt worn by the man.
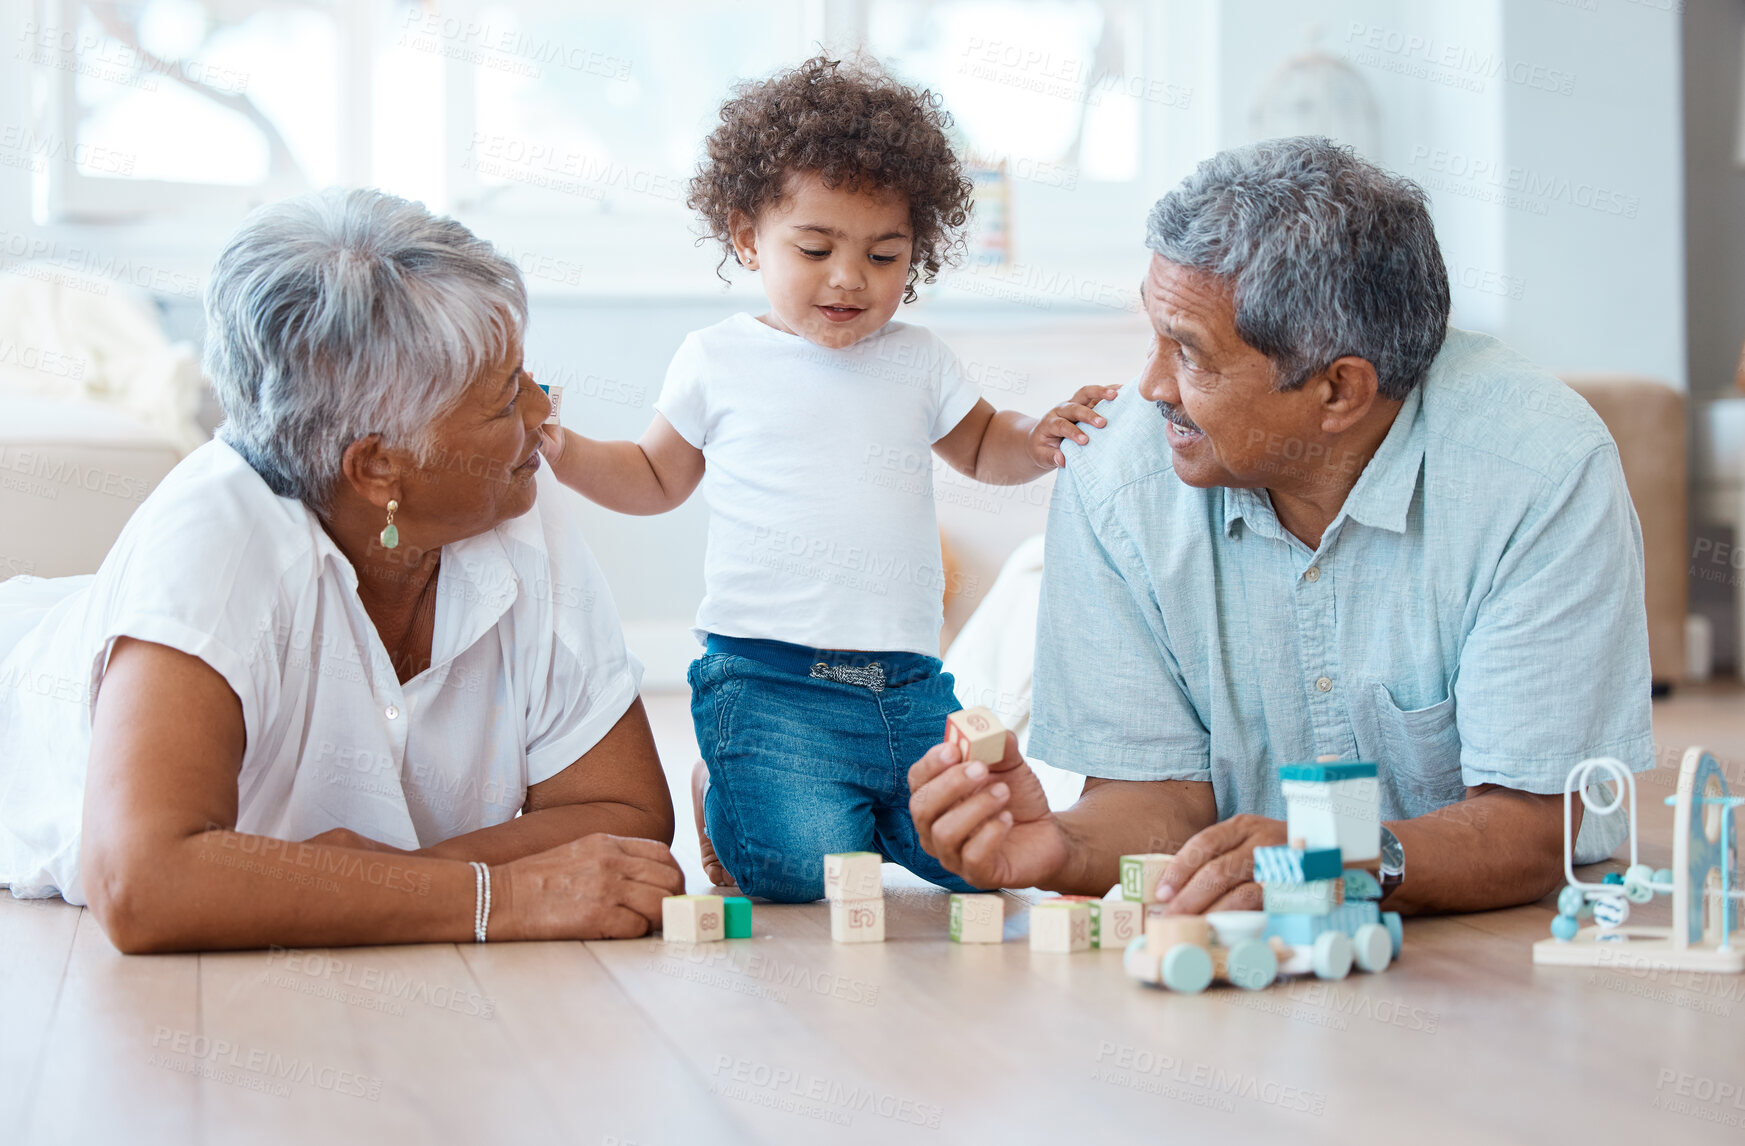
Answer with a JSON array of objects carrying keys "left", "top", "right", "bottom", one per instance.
[{"left": 1030, "top": 330, "right": 1654, "bottom": 858}]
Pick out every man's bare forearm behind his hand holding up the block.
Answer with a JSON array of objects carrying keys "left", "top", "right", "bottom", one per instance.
[{"left": 1044, "top": 776, "right": 1218, "bottom": 895}]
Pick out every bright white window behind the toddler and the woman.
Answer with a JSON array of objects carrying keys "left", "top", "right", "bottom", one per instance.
[{"left": 23, "top": 0, "right": 1192, "bottom": 290}]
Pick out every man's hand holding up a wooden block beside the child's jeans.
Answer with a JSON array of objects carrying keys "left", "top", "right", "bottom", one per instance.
[{"left": 909, "top": 733, "right": 1070, "bottom": 888}]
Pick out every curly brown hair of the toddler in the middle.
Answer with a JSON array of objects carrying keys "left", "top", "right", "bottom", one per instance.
[{"left": 686, "top": 56, "right": 974, "bottom": 302}]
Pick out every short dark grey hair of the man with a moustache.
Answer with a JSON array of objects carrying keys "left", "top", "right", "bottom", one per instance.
[{"left": 1145, "top": 136, "right": 1448, "bottom": 399}]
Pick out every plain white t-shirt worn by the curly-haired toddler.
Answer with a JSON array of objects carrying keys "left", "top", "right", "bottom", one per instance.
[{"left": 654, "top": 314, "right": 981, "bottom": 656}]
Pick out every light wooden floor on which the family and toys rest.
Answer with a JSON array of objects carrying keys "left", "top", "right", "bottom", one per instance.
[{"left": 0, "top": 689, "right": 1745, "bottom": 1146}]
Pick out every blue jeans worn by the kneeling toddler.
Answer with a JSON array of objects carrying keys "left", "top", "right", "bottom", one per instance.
[{"left": 689, "top": 637, "right": 975, "bottom": 904}]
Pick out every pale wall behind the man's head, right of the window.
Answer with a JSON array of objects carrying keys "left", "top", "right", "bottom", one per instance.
[{"left": 1216, "top": 0, "right": 1686, "bottom": 387}]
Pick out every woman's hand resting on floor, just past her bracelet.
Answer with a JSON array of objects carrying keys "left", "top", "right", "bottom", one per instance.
[{"left": 487, "top": 832, "right": 684, "bottom": 940}]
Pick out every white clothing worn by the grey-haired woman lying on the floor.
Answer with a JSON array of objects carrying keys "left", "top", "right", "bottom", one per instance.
[{"left": 0, "top": 441, "right": 642, "bottom": 904}]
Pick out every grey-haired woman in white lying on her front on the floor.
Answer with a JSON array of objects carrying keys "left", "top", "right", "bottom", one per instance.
[{"left": 0, "top": 190, "right": 684, "bottom": 952}]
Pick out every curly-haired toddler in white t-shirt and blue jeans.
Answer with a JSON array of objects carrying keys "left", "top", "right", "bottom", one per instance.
[{"left": 544, "top": 58, "right": 1115, "bottom": 902}]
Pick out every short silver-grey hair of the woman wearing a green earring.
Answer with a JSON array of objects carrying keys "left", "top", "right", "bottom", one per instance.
[{"left": 206, "top": 190, "right": 527, "bottom": 509}]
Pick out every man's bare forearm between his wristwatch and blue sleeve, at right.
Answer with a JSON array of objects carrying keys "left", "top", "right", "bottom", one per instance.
[{"left": 1386, "top": 785, "right": 1581, "bottom": 914}]
